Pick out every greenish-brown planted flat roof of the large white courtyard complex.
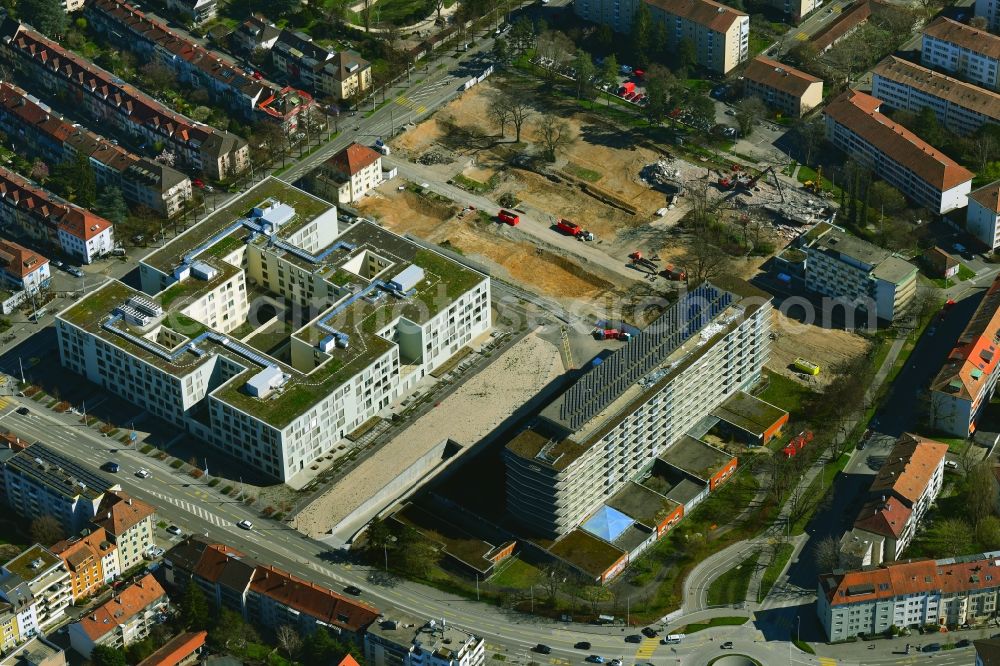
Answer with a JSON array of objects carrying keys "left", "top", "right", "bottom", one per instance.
[{"left": 60, "top": 178, "right": 487, "bottom": 428}]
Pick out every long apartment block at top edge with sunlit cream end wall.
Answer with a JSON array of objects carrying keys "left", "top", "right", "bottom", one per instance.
[{"left": 573, "top": 0, "right": 750, "bottom": 74}]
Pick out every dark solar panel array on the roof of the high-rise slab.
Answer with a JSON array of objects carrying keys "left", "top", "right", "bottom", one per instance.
[{"left": 559, "top": 282, "right": 735, "bottom": 430}]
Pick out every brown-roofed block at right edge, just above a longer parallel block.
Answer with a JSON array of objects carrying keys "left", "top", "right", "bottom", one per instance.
[{"left": 920, "top": 16, "right": 1000, "bottom": 90}]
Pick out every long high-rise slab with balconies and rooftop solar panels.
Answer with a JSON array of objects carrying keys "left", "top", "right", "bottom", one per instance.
[{"left": 504, "top": 281, "right": 771, "bottom": 536}]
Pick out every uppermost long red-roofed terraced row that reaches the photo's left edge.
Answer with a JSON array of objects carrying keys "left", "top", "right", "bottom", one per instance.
[{"left": 0, "top": 18, "right": 250, "bottom": 179}]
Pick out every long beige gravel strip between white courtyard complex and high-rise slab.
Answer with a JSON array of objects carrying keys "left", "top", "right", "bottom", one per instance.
[{"left": 294, "top": 333, "right": 565, "bottom": 537}]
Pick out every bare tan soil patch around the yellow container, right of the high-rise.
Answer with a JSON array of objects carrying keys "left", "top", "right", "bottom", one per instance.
[{"left": 767, "top": 309, "right": 872, "bottom": 388}]
